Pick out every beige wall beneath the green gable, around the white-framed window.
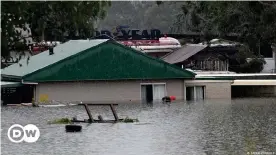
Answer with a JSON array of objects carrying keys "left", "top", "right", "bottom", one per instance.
[{"left": 35, "top": 80, "right": 184, "bottom": 102}]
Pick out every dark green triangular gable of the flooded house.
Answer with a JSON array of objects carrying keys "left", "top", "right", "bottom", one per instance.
[{"left": 24, "top": 41, "right": 195, "bottom": 82}]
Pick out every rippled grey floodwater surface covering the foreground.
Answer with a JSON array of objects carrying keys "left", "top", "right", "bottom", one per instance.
[{"left": 1, "top": 99, "right": 276, "bottom": 155}]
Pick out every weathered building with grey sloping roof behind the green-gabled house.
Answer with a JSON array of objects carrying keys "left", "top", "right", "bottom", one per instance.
[{"left": 162, "top": 41, "right": 237, "bottom": 71}]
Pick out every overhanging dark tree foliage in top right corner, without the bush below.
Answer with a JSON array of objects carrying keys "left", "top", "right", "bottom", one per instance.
[{"left": 179, "top": 1, "right": 276, "bottom": 46}]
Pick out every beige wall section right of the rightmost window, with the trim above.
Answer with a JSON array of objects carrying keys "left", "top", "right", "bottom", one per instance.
[{"left": 185, "top": 80, "right": 232, "bottom": 99}]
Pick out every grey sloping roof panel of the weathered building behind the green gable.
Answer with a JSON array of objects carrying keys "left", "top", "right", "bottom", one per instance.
[{"left": 162, "top": 44, "right": 207, "bottom": 64}]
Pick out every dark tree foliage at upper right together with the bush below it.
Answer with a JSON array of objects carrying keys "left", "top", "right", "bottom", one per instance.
[{"left": 176, "top": 1, "right": 276, "bottom": 73}]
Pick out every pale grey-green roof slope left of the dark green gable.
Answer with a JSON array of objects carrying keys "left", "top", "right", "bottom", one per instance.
[{"left": 1, "top": 39, "right": 108, "bottom": 77}]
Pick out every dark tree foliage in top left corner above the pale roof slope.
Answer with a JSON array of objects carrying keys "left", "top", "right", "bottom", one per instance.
[{"left": 1, "top": 1, "right": 111, "bottom": 61}]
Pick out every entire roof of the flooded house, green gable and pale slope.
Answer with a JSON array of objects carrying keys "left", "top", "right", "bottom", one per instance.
[{"left": 2, "top": 40, "right": 195, "bottom": 82}]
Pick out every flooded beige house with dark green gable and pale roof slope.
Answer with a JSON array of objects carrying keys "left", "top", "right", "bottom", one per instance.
[{"left": 1, "top": 39, "right": 195, "bottom": 104}]
